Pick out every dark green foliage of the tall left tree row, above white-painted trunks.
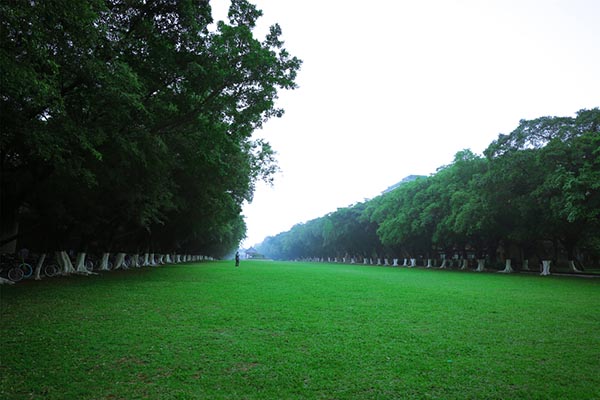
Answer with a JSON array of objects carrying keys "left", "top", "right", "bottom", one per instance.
[{"left": 0, "top": 0, "right": 301, "bottom": 257}]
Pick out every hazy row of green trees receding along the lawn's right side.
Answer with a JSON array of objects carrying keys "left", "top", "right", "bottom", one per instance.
[{"left": 257, "top": 108, "right": 600, "bottom": 273}]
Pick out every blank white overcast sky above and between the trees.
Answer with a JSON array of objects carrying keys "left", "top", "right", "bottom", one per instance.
[{"left": 211, "top": 0, "right": 600, "bottom": 247}]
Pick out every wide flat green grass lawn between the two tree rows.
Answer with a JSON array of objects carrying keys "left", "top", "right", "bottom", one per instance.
[{"left": 0, "top": 261, "right": 600, "bottom": 399}]
